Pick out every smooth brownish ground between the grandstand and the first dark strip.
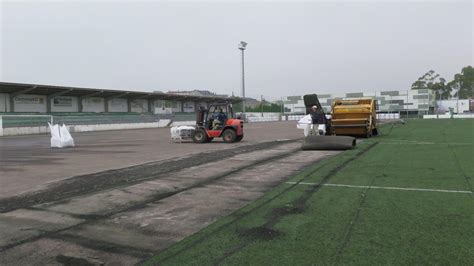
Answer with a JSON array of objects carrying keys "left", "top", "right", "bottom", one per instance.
[{"left": 0, "top": 122, "right": 302, "bottom": 198}]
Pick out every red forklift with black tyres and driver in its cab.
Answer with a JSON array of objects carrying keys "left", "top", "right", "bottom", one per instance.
[{"left": 191, "top": 102, "right": 244, "bottom": 143}]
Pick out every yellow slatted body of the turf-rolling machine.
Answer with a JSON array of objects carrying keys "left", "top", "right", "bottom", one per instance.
[{"left": 330, "top": 99, "right": 378, "bottom": 138}]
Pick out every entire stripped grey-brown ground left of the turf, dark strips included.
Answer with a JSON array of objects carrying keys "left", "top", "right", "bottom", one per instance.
[{"left": 0, "top": 122, "right": 336, "bottom": 265}]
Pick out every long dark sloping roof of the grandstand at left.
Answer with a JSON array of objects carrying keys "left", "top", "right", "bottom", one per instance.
[{"left": 0, "top": 82, "right": 241, "bottom": 103}]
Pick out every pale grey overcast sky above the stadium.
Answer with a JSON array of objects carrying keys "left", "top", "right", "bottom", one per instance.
[{"left": 0, "top": 0, "right": 474, "bottom": 99}]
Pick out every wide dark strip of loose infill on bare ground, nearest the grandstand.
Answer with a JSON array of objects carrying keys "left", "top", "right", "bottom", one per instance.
[{"left": 0, "top": 140, "right": 295, "bottom": 213}]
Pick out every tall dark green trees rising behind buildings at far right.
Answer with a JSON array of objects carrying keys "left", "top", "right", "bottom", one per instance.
[{"left": 411, "top": 66, "right": 474, "bottom": 100}]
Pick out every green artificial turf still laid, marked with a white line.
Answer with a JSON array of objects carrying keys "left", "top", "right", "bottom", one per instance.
[{"left": 145, "top": 119, "right": 474, "bottom": 265}]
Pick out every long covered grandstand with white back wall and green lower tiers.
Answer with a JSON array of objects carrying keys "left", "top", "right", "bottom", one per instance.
[{"left": 0, "top": 82, "right": 240, "bottom": 136}]
